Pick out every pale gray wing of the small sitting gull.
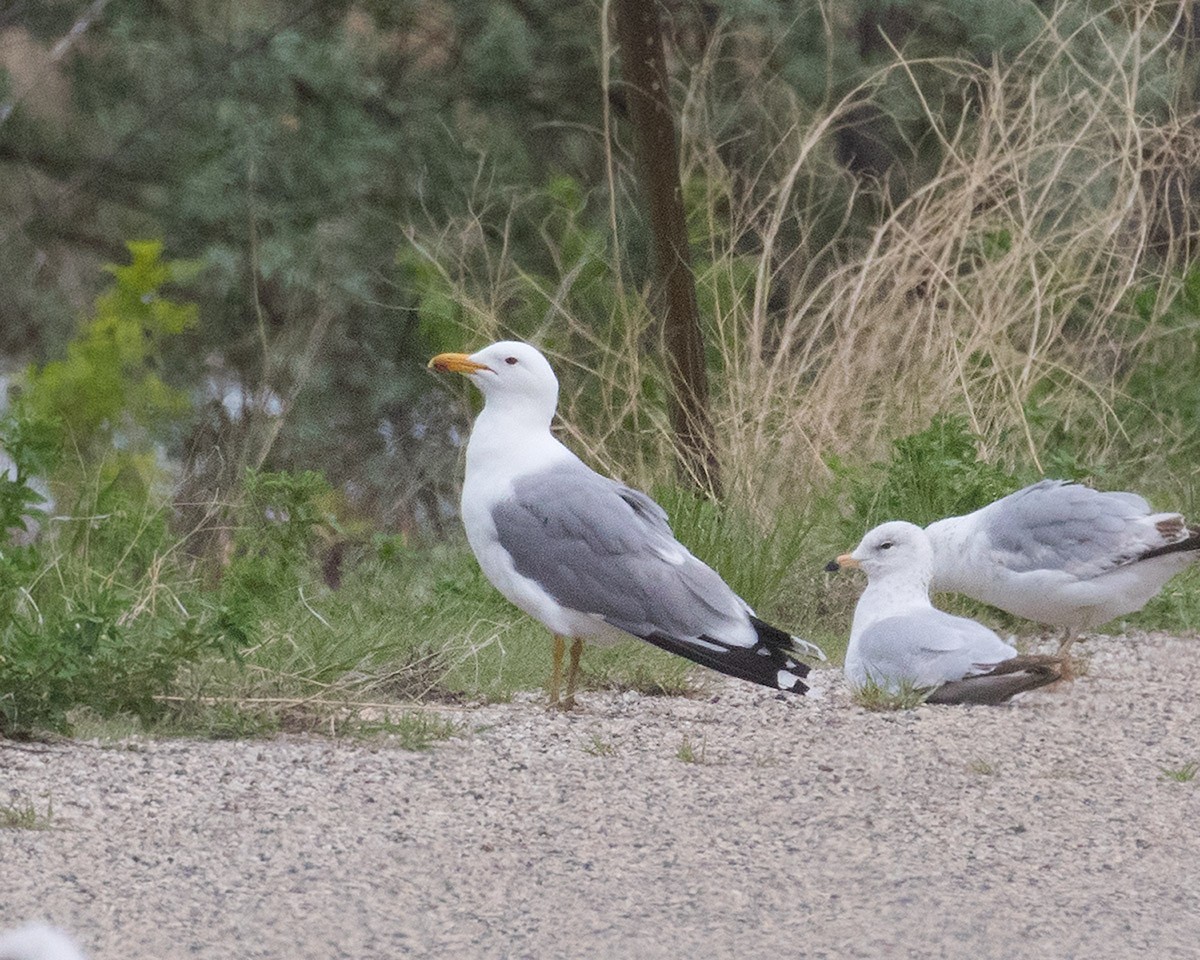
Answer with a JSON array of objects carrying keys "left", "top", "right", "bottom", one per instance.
[{"left": 858, "top": 610, "right": 1016, "bottom": 689}]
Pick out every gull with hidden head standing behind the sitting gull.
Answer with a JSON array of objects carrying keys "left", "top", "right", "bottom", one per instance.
[{"left": 926, "top": 480, "right": 1200, "bottom": 655}]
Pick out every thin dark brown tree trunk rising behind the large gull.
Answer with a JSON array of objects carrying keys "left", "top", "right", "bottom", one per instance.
[{"left": 616, "top": 0, "right": 721, "bottom": 496}]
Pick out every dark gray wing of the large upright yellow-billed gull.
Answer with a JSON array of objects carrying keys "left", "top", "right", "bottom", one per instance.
[{"left": 492, "top": 462, "right": 754, "bottom": 646}]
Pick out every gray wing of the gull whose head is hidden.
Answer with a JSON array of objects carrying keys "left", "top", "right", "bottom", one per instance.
[{"left": 984, "top": 480, "right": 1154, "bottom": 578}]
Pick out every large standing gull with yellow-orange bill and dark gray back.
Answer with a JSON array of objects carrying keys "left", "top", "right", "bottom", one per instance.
[{"left": 430, "top": 341, "right": 821, "bottom": 709}]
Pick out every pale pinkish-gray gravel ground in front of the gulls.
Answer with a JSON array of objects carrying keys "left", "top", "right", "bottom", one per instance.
[{"left": 0, "top": 635, "right": 1200, "bottom": 960}]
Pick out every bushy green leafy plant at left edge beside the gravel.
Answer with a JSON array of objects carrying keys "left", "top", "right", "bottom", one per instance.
[{"left": 0, "top": 417, "right": 248, "bottom": 736}]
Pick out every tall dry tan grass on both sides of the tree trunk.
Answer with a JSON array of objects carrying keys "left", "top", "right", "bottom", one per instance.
[{"left": 412, "top": 2, "right": 1200, "bottom": 518}]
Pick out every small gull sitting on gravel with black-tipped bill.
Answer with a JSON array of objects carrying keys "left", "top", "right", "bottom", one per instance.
[{"left": 826, "top": 520, "right": 1062, "bottom": 703}]
